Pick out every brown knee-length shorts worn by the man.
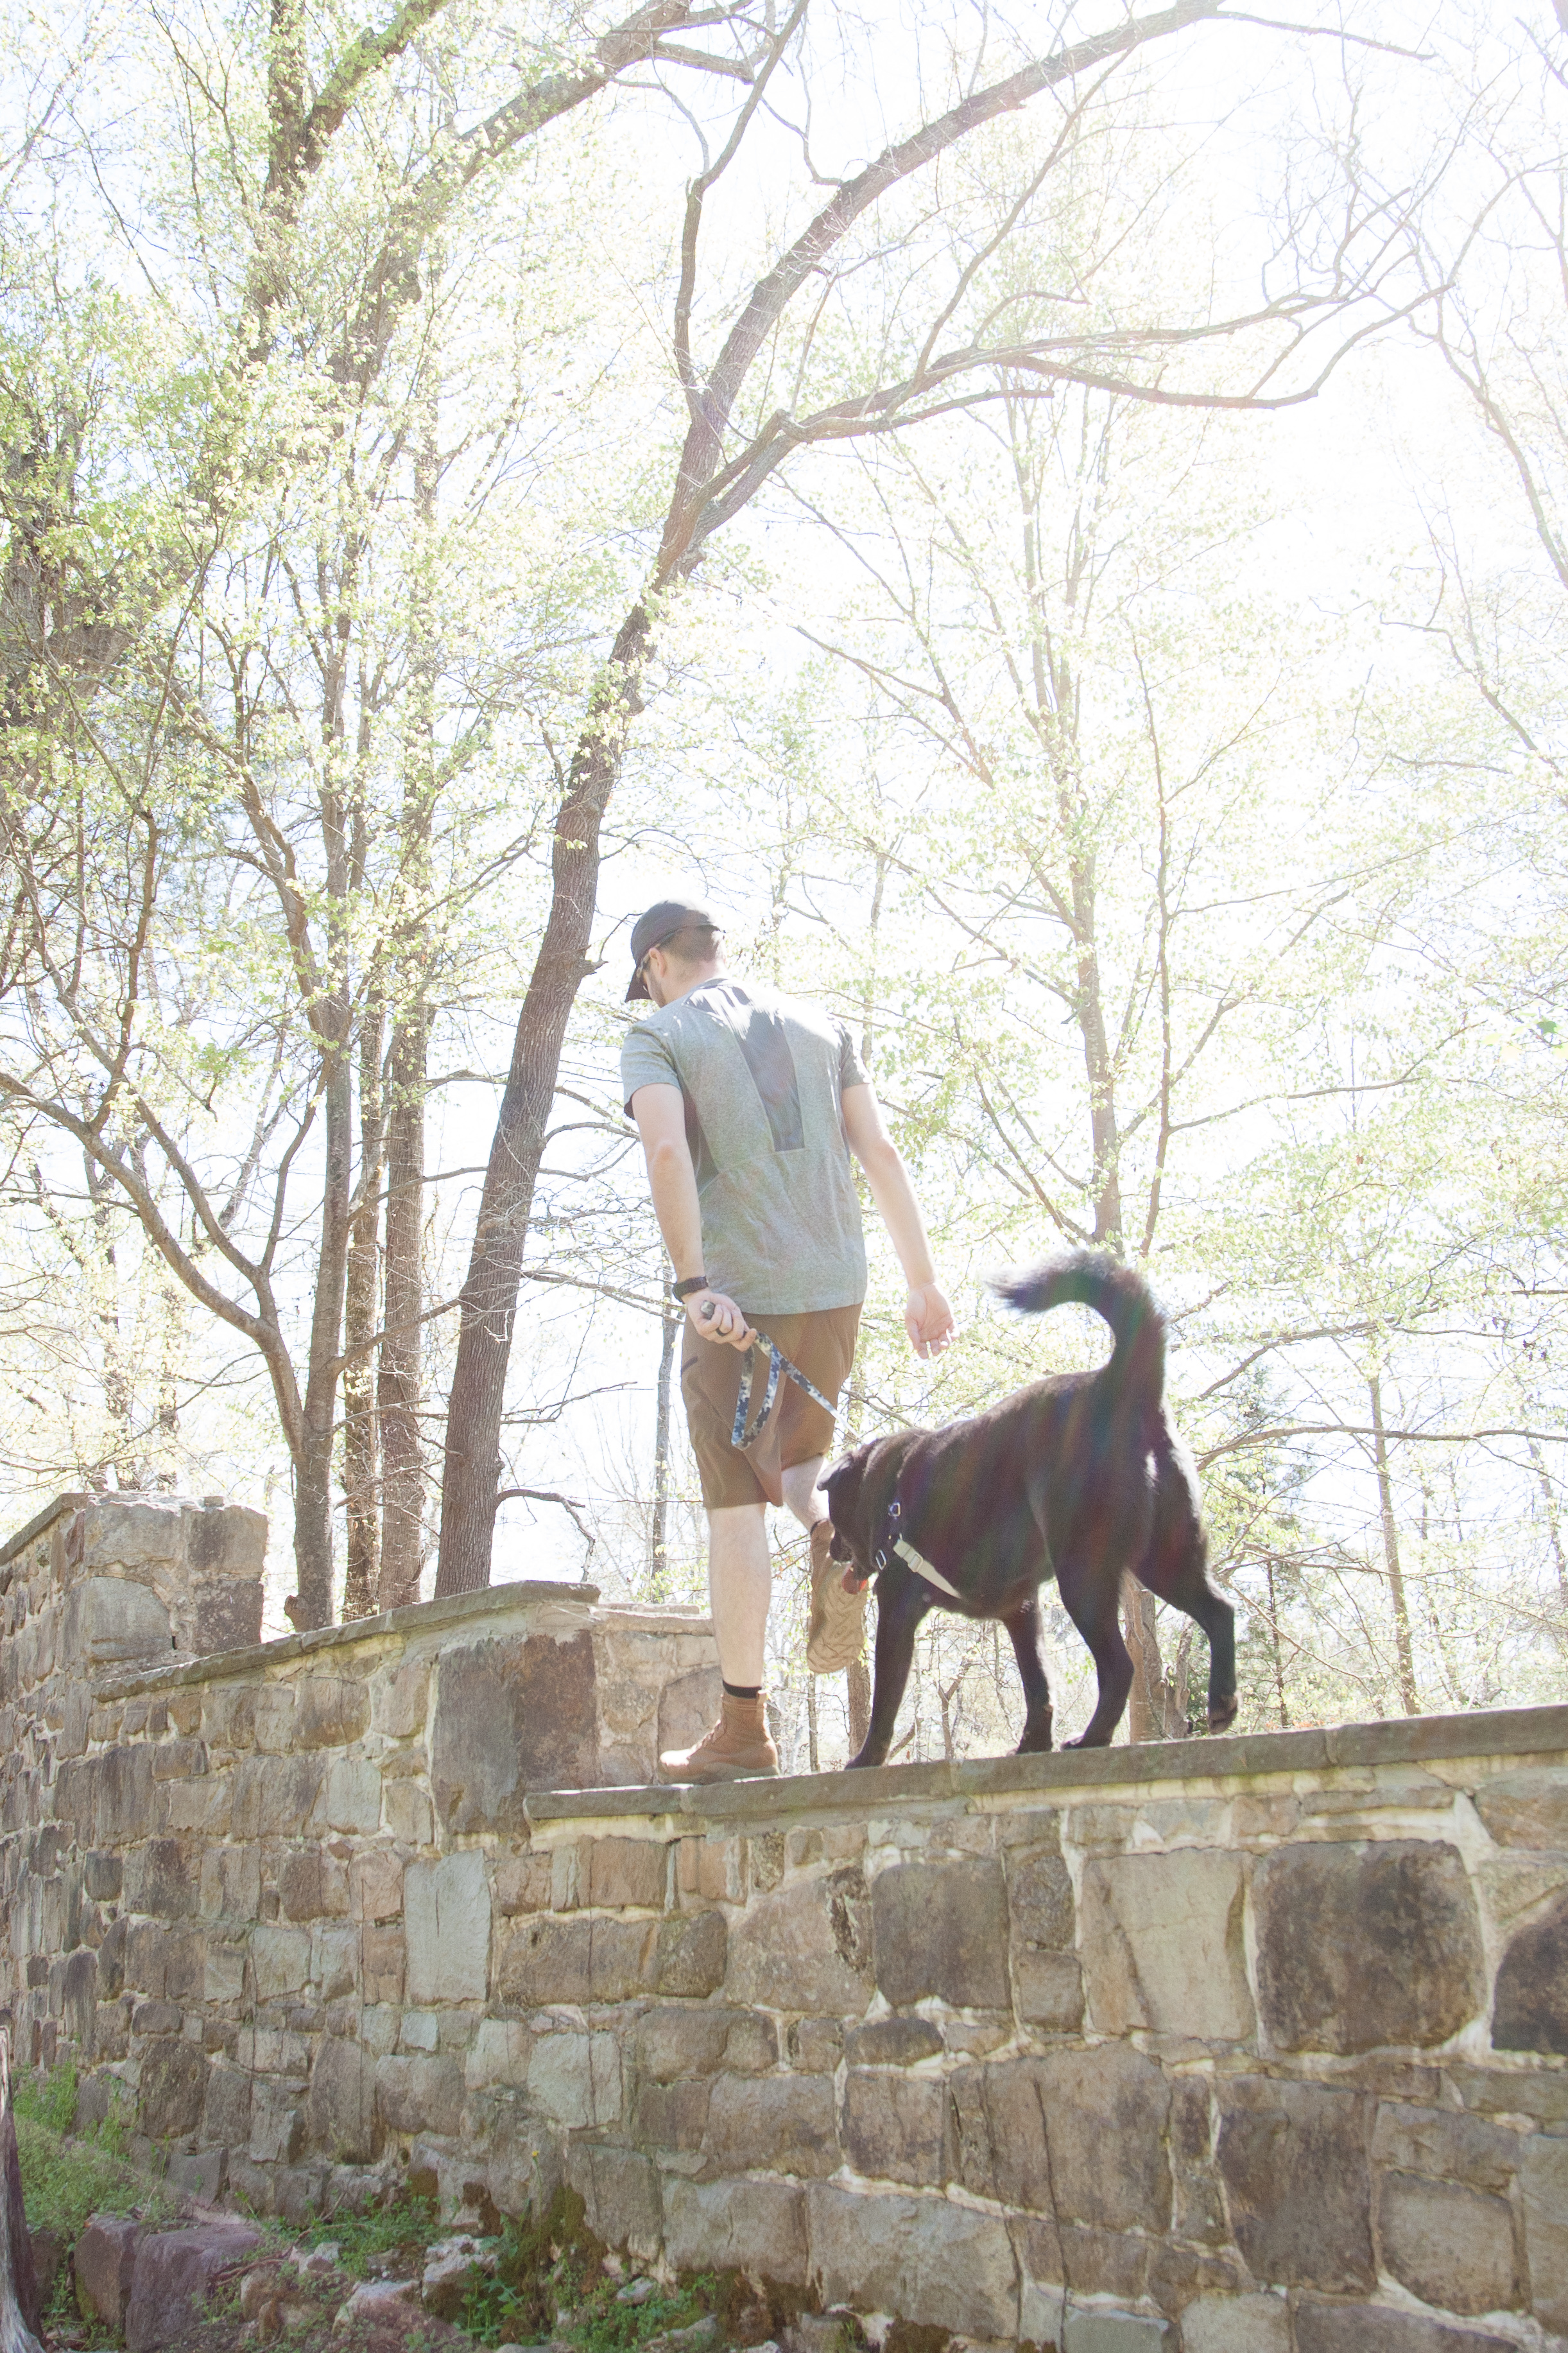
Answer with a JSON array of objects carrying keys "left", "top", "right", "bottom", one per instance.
[{"left": 682, "top": 1303, "right": 861, "bottom": 1511}]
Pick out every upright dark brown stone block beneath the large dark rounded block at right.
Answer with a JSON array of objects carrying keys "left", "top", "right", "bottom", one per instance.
[{"left": 1216, "top": 2076, "right": 1375, "bottom": 2292}]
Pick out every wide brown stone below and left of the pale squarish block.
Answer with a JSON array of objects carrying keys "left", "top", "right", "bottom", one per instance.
[{"left": 947, "top": 2042, "right": 1171, "bottom": 2230}]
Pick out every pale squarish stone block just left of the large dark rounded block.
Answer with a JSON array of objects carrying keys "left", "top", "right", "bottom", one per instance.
[{"left": 1079, "top": 1847, "right": 1255, "bottom": 2042}]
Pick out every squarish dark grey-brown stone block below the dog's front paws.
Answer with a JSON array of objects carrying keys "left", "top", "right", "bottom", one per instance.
[{"left": 872, "top": 1857, "right": 1011, "bottom": 2010}]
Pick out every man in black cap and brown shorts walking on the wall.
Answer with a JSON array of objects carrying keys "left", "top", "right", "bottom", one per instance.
[{"left": 621, "top": 899, "right": 952, "bottom": 1781}]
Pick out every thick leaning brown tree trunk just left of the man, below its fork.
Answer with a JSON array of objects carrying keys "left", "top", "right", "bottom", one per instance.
[{"left": 435, "top": 605, "right": 651, "bottom": 1595}]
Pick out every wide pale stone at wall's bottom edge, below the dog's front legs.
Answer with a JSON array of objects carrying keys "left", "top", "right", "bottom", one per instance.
[{"left": 809, "top": 2184, "right": 1018, "bottom": 2339}]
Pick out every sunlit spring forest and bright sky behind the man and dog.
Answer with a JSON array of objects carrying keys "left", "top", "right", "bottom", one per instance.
[{"left": 0, "top": 0, "right": 1568, "bottom": 1767}]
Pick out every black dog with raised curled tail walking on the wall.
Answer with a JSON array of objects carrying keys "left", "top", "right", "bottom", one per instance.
[{"left": 823, "top": 1249, "right": 1237, "bottom": 1765}]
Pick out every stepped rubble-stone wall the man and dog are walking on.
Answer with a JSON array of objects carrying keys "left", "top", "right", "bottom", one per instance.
[{"left": 0, "top": 1496, "right": 1568, "bottom": 2353}]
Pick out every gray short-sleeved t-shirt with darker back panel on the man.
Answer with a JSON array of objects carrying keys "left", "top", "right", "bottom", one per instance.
[{"left": 621, "top": 979, "right": 868, "bottom": 1315}]
